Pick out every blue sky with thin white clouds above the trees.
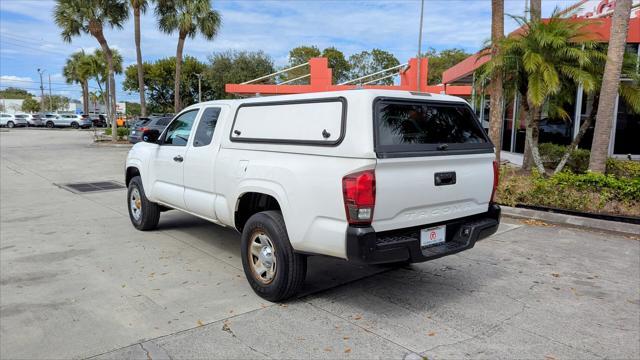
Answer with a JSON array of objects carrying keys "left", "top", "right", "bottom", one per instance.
[{"left": 0, "top": 0, "right": 576, "bottom": 100}]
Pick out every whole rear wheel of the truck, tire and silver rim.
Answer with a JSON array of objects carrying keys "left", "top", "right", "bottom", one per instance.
[{"left": 241, "top": 211, "right": 307, "bottom": 301}]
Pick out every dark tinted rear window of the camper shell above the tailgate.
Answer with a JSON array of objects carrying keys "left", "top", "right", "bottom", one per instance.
[{"left": 373, "top": 98, "right": 493, "bottom": 158}]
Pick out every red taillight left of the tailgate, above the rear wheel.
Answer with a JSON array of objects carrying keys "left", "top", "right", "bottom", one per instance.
[{"left": 342, "top": 170, "right": 376, "bottom": 225}]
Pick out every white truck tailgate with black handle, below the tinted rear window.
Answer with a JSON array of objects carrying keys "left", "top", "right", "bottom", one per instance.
[{"left": 371, "top": 154, "right": 494, "bottom": 231}]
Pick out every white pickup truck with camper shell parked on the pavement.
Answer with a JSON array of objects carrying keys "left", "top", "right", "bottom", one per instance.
[{"left": 126, "top": 90, "right": 500, "bottom": 301}]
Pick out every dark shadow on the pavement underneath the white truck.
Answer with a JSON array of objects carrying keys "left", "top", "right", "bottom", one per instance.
[{"left": 157, "top": 211, "right": 475, "bottom": 310}]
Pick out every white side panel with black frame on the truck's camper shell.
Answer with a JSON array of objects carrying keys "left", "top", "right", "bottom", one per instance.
[{"left": 229, "top": 97, "right": 347, "bottom": 146}]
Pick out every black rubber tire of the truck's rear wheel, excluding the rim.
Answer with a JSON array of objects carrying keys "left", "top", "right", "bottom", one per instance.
[{"left": 241, "top": 210, "right": 307, "bottom": 302}]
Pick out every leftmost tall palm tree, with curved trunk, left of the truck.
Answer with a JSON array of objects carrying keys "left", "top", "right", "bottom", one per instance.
[{"left": 54, "top": 0, "right": 129, "bottom": 142}]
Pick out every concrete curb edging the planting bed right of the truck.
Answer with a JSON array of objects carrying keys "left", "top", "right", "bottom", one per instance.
[{"left": 500, "top": 205, "right": 640, "bottom": 236}]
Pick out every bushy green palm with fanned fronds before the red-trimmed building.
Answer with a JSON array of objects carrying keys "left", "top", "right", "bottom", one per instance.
[{"left": 479, "top": 12, "right": 602, "bottom": 174}]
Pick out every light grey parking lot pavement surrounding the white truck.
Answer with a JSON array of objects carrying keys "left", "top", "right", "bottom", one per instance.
[{"left": 0, "top": 129, "right": 640, "bottom": 360}]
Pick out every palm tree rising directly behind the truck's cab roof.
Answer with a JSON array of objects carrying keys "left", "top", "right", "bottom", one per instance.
[{"left": 156, "top": 0, "right": 222, "bottom": 113}]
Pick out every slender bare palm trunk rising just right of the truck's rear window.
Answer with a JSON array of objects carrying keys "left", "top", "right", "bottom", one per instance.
[{"left": 489, "top": 0, "right": 504, "bottom": 163}]
